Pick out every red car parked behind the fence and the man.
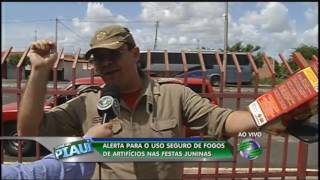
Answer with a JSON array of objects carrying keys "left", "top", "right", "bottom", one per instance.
[{"left": 2, "top": 77, "right": 217, "bottom": 156}]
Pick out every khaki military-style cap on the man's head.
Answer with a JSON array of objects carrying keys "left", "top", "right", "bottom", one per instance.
[{"left": 85, "top": 25, "right": 135, "bottom": 59}]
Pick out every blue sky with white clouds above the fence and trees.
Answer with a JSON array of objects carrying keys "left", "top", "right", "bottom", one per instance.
[{"left": 1, "top": 2, "right": 319, "bottom": 59}]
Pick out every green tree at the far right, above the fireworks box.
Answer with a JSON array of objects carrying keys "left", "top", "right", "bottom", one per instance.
[{"left": 288, "top": 44, "right": 319, "bottom": 72}]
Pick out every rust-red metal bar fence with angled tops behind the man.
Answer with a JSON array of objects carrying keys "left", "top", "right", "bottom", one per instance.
[{"left": 1, "top": 47, "right": 318, "bottom": 179}]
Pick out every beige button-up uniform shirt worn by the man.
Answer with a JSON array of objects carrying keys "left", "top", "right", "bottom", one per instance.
[{"left": 40, "top": 74, "right": 232, "bottom": 179}]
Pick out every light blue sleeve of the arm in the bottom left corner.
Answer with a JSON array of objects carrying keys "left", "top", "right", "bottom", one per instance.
[{"left": 1, "top": 154, "right": 95, "bottom": 179}]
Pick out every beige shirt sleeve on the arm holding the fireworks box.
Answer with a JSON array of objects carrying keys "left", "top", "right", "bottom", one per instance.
[{"left": 182, "top": 87, "right": 233, "bottom": 140}]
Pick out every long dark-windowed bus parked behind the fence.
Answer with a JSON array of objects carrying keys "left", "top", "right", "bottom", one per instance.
[{"left": 140, "top": 51, "right": 252, "bottom": 85}]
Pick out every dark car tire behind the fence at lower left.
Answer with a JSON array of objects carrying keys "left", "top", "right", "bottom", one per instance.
[{"left": 3, "top": 123, "right": 35, "bottom": 156}]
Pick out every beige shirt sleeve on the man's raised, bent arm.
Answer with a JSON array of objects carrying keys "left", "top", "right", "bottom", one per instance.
[{"left": 39, "top": 96, "right": 85, "bottom": 136}]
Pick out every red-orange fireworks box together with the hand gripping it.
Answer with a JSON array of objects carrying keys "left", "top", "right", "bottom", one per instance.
[{"left": 249, "top": 59, "right": 318, "bottom": 142}]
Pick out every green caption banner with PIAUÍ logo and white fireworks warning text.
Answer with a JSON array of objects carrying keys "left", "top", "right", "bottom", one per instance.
[{"left": 53, "top": 138, "right": 233, "bottom": 162}]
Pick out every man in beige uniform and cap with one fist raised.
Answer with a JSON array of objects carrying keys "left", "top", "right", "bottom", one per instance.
[{"left": 18, "top": 25, "right": 280, "bottom": 179}]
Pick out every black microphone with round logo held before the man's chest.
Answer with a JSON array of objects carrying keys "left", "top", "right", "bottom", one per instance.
[{"left": 97, "top": 84, "right": 120, "bottom": 124}]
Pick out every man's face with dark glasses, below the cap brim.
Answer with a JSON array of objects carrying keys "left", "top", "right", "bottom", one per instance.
[{"left": 92, "top": 45, "right": 139, "bottom": 87}]
